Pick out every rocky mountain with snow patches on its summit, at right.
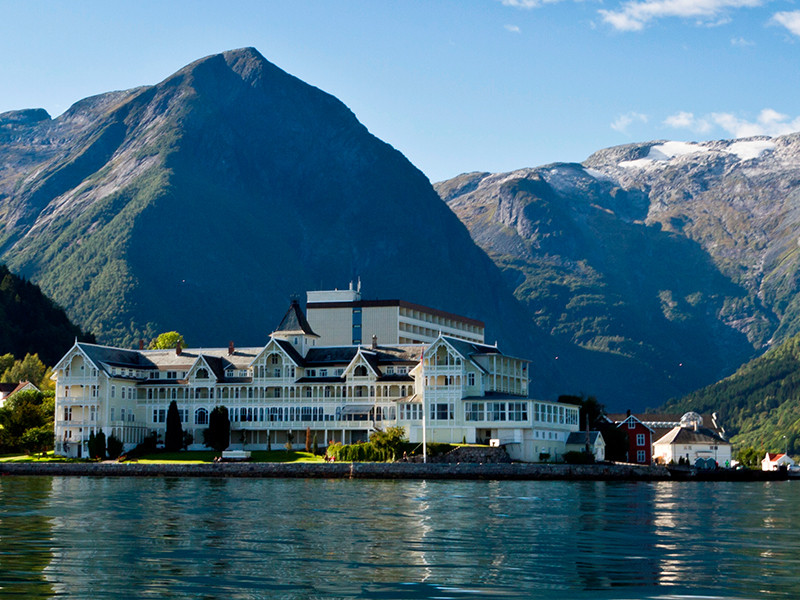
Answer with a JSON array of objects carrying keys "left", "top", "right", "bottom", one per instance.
[{"left": 435, "top": 134, "right": 800, "bottom": 406}]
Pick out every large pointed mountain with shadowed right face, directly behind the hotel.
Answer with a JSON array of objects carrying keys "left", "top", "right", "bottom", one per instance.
[{"left": 0, "top": 48, "right": 561, "bottom": 391}]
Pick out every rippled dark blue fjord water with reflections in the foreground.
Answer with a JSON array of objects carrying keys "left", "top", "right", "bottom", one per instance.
[{"left": 0, "top": 477, "right": 800, "bottom": 600}]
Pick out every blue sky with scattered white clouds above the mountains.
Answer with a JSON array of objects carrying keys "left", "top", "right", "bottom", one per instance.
[{"left": 0, "top": 0, "right": 800, "bottom": 181}]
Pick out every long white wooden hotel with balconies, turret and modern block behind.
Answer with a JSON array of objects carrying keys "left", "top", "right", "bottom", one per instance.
[{"left": 53, "top": 289, "right": 579, "bottom": 462}]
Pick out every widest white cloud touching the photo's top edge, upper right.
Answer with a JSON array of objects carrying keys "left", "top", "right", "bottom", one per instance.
[{"left": 600, "top": 0, "right": 765, "bottom": 31}]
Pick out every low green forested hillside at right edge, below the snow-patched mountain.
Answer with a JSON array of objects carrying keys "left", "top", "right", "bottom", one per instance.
[{"left": 665, "top": 334, "right": 800, "bottom": 455}]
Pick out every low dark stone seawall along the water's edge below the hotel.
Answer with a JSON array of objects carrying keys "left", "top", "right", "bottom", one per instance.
[{"left": 0, "top": 462, "right": 787, "bottom": 481}]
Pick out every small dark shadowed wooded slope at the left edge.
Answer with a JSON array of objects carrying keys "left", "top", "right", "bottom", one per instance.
[{"left": 0, "top": 265, "right": 94, "bottom": 366}]
